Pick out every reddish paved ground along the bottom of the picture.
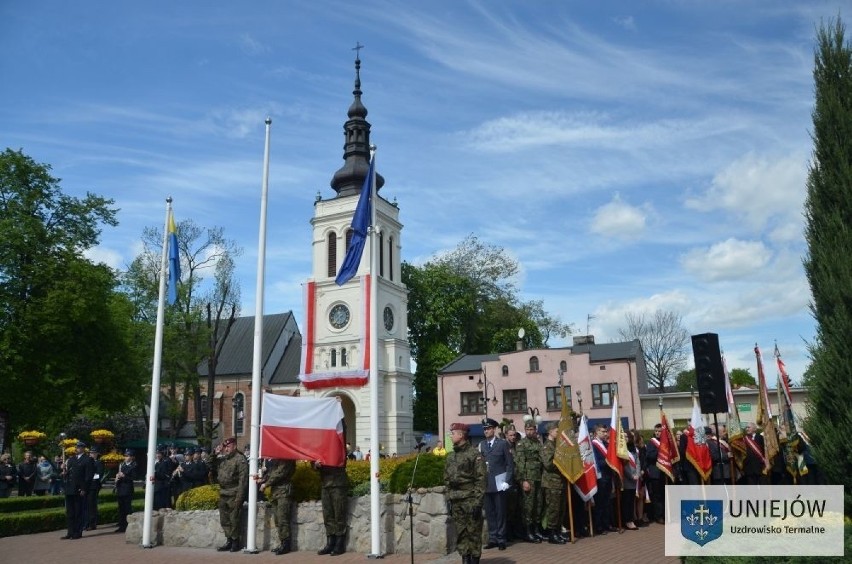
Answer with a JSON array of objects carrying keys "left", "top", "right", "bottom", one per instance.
[{"left": 0, "top": 525, "right": 679, "bottom": 564}]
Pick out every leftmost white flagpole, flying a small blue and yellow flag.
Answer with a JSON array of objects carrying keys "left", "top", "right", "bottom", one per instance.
[{"left": 142, "top": 196, "right": 172, "bottom": 548}]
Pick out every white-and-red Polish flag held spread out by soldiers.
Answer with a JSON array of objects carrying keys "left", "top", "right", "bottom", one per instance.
[{"left": 260, "top": 394, "right": 346, "bottom": 466}]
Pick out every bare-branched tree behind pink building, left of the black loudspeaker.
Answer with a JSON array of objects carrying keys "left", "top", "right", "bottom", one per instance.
[{"left": 618, "top": 310, "right": 690, "bottom": 392}]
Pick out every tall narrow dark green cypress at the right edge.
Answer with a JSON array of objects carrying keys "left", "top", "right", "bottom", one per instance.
[{"left": 804, "top": 18, "right": 852, "bottom": 515}]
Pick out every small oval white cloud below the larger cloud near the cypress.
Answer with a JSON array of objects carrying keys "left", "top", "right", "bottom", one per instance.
[{"left": 681, "top": 238, "right": 772, "bottom": 282}]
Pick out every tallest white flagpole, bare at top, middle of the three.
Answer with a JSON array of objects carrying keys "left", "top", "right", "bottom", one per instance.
[{"left": 243, "top": 117, "right": 272, "bottom": 554}]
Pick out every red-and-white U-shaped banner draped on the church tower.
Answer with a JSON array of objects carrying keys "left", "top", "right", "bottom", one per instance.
[{"left": 299, "top": 275, "right": 372, "bottom": 390}]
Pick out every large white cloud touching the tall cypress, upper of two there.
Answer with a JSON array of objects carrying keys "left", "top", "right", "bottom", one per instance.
[{"left": 685, "top": 153, "right": 807, "bottom": 234}]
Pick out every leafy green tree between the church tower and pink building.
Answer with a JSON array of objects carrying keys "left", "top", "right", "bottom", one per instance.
[{"left": 402, "top": 235, "right": 570, "bottom": 431}]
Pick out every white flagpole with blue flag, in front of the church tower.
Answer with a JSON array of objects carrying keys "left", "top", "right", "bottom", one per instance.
[{"left": 370, "top": 145, "right": 383, "bottom": 558}]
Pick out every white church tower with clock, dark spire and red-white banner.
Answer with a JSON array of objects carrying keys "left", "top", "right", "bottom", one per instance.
[{"left": 300, "top": 57, "right": 415, "bottom": 456}]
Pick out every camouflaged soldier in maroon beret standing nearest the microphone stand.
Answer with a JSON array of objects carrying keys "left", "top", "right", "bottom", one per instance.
[{"left": 444, "top": 423, "right": 487, "bottom": 564}]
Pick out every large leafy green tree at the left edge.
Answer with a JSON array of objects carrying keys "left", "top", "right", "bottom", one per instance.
[{"left": 0, "top": 149, "right": 144, "bottom": 431}]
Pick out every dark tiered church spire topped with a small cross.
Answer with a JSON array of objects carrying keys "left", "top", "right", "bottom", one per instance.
[{"left": 331, "top": 49, "right": 385, "bottom": 196}]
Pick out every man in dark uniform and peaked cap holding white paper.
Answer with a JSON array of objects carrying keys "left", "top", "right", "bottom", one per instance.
[{"left": 479, "top": 418, "right": 515, "bottom": 550}]
